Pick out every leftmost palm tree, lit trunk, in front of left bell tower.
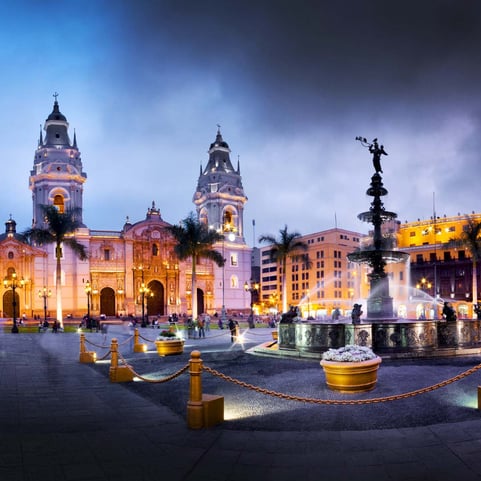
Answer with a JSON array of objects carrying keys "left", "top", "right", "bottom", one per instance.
[{"left": 23, "top": 205, "right": 87, "bottom": 326}]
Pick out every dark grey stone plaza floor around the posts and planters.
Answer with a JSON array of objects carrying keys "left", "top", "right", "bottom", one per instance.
[{"left": 0, "top": 326, "right": 481, "bottom": 481}]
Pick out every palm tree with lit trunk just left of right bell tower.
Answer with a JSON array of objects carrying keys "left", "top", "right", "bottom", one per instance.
[{"left": 168, "top": 212, "right": 225, "bottom": 320}]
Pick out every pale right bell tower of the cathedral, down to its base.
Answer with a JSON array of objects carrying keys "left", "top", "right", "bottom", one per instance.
[{"left": 193, "top": 128, "right": 251, "bottom": 313}]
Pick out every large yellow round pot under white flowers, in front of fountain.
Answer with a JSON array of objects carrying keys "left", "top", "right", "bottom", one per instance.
[{"left": 321, "top": 357, "right": 382, "bottom": 393}]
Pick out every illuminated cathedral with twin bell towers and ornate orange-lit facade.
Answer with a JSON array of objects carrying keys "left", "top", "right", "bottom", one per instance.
[{"left": 0, "top": 96, "right": 252, "bottom": 318}]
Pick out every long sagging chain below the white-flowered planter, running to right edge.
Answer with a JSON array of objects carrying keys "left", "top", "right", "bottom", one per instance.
[{"left": 203, "top": 364, "right": 481, "bottom": 405}]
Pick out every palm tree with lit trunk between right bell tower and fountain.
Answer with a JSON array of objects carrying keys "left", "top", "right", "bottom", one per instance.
[{"left": 259, "top": 225, "right": 308, "bottom": 312}]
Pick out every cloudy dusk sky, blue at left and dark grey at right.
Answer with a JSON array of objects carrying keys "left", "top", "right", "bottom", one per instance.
[{"left": 0, "top": 0, "right": 481, "bottom": 244}]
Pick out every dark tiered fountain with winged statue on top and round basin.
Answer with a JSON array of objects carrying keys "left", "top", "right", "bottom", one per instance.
[{"left": 268, "top": 137, "right": 481, "bottom": 357}]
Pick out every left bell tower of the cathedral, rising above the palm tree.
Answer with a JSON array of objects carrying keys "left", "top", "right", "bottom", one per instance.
[{"left": 29, "top": 94, "right": 87, "bottom": 228}]
